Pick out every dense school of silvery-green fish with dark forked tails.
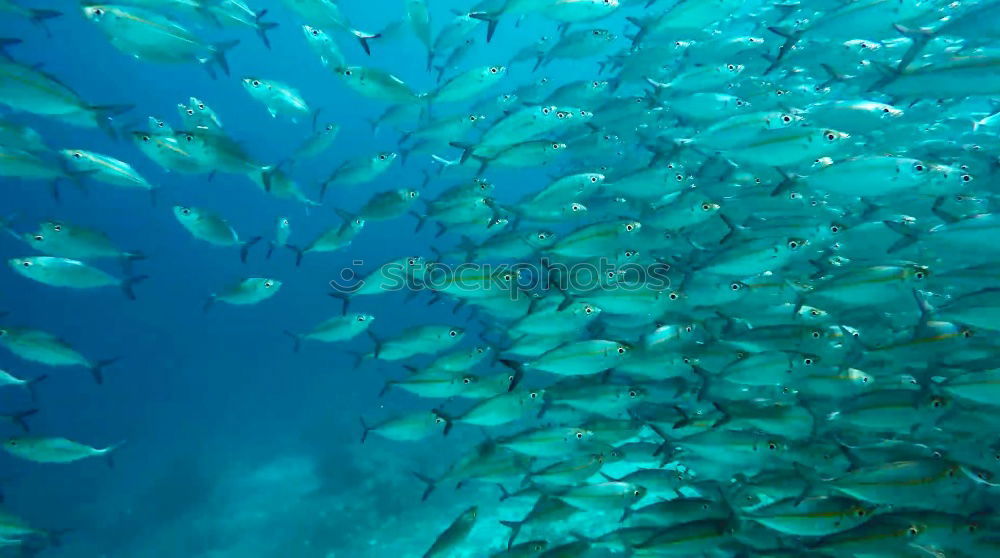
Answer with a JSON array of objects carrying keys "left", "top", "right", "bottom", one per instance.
[{"left": 0, "top": 0, "right": 1000, "bottom": 558}]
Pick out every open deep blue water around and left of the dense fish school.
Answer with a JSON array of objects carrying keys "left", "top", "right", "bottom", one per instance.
[{"left": 0, "top": 0, "right": 596, "bottom": 558}]
